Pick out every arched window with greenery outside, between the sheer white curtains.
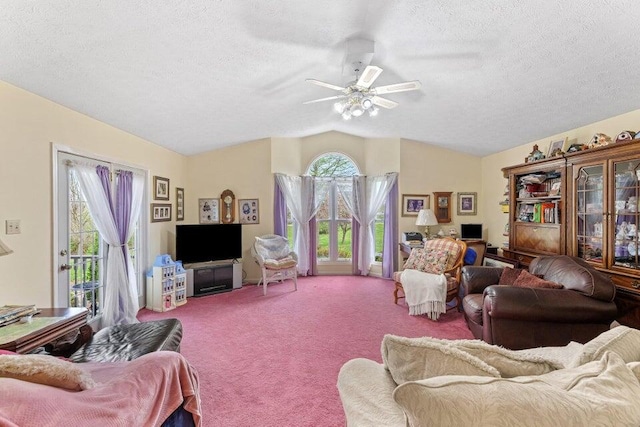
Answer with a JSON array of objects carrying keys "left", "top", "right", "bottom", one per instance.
[{"left": 307, "top": 153, "right": 360, "bottom": 262}]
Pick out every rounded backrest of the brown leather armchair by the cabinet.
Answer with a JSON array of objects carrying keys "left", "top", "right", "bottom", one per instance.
[{"left": 529, "top": 255, "right": 616, "bottom": 302}]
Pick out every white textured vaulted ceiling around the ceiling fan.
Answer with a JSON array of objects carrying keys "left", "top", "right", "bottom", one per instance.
[{"left": 0, "top": 0, "right": 640, "bottom": 155}]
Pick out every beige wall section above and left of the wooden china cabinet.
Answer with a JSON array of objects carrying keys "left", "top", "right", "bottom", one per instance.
[{"left": 481, "top": 110, "right": 640, "bottom": 251}]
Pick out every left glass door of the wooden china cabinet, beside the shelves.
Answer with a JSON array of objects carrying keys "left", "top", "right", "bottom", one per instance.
[{"left": 575, "top": 165, "right": 605, "bottom": 264}]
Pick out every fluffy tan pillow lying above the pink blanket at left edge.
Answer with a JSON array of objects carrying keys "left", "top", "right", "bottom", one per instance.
[{"left": 0, "top": 354, "right": 95, "bottom": 391}]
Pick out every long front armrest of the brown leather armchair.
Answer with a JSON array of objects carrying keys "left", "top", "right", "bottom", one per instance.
[{"left": 483, "top": 286, "right": 617, "bottom": 323}]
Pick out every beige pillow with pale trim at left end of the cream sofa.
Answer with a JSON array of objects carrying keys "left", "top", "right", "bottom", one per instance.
[{"left": 381, "top": 335, "right": 500, "bottom": 384}]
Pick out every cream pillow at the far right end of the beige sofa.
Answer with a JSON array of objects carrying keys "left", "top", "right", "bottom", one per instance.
[{"left": 571, "top": 325, "right": 640, "bottom": 366}]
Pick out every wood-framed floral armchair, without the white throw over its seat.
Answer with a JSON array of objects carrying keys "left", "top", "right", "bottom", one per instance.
[{"left": 393, "top": 237, "right": 467, "bottom": 316}]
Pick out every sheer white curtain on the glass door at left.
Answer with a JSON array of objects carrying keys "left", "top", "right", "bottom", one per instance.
[{"left": 72, "top": 162, "right": 144, "bottom": 327}]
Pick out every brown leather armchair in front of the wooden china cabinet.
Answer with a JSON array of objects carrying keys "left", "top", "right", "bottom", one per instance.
[{"left": 461, "top": 255, "right": 617, "bottom": 350}]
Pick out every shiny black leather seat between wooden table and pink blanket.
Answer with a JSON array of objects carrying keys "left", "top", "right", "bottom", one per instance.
[{"left": 69, "top": 319, "right": 182, "bottom": 362}]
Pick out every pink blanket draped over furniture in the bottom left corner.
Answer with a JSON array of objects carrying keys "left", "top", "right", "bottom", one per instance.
[{"left": 0, "top": 351, "right": 202, "bottom": 427}]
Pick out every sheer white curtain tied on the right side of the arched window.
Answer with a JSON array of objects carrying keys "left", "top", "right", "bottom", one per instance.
[{"left": 338, "top": 172, "right": 398, "bottom": 276}]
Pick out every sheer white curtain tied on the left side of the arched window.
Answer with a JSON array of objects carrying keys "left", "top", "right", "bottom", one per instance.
[{"left": 276, "top": 174, "right": 329, "bottom": 276}]
